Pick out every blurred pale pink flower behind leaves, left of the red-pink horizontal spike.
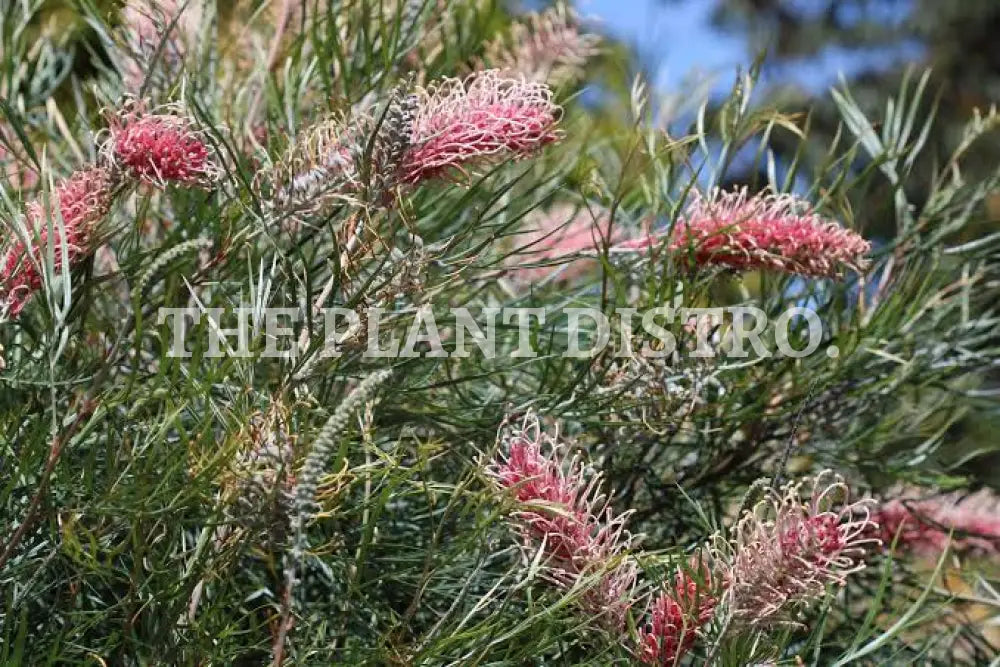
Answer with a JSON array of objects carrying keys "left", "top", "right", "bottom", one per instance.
[{"left": 507, "top": 204, "right": 622, "bottom": 282}]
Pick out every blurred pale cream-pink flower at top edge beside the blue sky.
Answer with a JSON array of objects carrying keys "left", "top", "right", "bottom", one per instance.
[{"left": 486, "top": 4, "right": 600, "bottom": 85}]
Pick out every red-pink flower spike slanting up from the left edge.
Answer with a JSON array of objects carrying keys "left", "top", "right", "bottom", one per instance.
[{"left": 0, "top": 168, "right": 114, "bottom": 317}]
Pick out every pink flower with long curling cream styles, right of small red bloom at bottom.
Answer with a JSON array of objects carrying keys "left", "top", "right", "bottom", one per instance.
[{"left": 720, "top": 472, "right": 878, "bottom": 627}]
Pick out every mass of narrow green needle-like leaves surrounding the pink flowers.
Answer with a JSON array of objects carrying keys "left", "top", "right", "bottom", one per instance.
[{"left": 0, "top": 0, "right": 1000, "bottom": 665}]
